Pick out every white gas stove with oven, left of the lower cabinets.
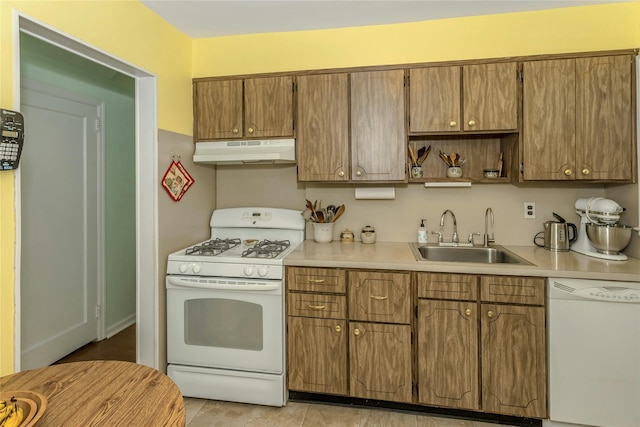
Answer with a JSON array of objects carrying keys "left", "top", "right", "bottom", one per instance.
[{"left": 166, "top": 208, "right": 305, "bottom": 406}]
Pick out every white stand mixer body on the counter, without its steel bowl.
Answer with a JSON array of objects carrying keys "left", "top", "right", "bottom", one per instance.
[{"left": 571, "top": 197, "right": 627, "bottom": 261}]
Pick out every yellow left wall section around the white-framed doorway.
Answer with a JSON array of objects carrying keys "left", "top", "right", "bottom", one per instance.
[{"left": 0, "top": 0, "right": 192, "bottom": 375}]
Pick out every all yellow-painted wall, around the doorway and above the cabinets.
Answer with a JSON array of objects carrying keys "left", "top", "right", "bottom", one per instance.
[{"left": 0, "top": 0, "right": 640, "bottom": 375}]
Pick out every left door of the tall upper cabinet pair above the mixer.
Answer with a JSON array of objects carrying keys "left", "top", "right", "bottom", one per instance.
[{"left": 522, "top": 59, "right": 576, "bottom": 180}]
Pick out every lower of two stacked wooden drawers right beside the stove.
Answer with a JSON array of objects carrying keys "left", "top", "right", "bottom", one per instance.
[{"left": 287, "top": 293, "right": 347, "bottom": 319}]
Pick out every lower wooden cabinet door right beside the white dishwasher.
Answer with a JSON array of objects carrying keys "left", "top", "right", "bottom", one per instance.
[{"left": 480, "top": 304, "right": 547, "bottom": 418}]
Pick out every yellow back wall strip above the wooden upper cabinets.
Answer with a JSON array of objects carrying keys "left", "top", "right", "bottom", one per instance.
[{"left": 193, "top": 2, "right": 640, "bottom": 77}]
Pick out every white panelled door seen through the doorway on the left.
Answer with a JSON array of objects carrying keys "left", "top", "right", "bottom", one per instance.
[{"left": 20, "top": 84, "right": 102, "bottom": 370}]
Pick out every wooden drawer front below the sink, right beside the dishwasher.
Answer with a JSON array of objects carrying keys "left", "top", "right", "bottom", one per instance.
[{"left": 480, "top": 276, "right": 545, "bottom": 305}]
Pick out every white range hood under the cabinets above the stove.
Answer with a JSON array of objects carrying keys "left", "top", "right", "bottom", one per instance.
[{"left": 193, "top": 138, "right": 296, "bottom": 165}]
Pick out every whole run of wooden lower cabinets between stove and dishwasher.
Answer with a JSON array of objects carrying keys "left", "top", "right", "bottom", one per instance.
[{"left": 287, "top": 268, "right": 547, "bottom": 419}]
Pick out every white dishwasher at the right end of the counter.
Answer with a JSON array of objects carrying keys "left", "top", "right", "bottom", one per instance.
[{"left": 543, "top": 278, "right": 640, "bottom": 427}]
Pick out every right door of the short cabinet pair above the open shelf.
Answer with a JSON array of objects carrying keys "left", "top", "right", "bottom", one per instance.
[{"left": 463, "top": 62, "right": 518, "bottom": 131}]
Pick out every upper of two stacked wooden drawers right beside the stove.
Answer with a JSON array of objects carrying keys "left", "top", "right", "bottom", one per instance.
[{"left": 287, "top": 267, "right": 347, "bottom": 294}]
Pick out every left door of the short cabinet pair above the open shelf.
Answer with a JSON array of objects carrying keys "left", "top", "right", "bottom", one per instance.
[{"left": 409, "top": 67, "right": 462, "bottom": 133}]
